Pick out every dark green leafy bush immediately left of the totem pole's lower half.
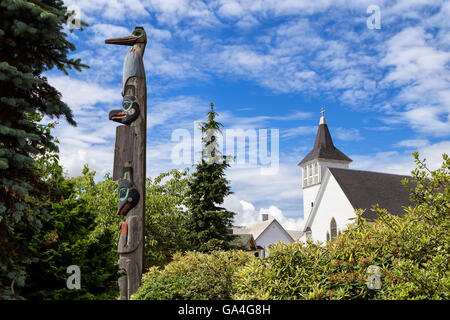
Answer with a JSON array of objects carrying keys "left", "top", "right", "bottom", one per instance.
[{"left": 21, "top": 167, "right": 118, "bottom": 299}]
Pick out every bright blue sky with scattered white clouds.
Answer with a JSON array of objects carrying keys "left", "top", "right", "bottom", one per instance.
[{"left": 47, "top": 0, "right": 450, "bottom": 229}]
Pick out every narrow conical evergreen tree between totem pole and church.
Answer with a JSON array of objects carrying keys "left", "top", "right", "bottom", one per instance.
[{"left": 187, "top": 103, "right": 235, "bottom": 251}]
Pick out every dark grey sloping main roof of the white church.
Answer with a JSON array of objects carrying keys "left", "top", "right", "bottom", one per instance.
[{"left": 328, "top": 168, "right": 411, "bottom": 219}]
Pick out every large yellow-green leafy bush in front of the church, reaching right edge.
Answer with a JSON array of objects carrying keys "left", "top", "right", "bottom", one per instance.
[{"left": 233, "top": 154, "right": 450, "bottom": 299}]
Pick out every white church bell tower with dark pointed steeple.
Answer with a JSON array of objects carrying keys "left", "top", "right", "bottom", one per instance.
[{"left": 298, "top": 108, "right": 352, "bottom": 222}]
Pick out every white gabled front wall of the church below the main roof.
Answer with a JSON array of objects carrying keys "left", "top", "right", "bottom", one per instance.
[{"left": 311, "top": 173, "right": 355, "bottom": 242}]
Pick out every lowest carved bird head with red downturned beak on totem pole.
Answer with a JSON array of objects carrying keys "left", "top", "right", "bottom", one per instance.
[{"left": 117, "top": 164, "right": 140, "bottom": 216}]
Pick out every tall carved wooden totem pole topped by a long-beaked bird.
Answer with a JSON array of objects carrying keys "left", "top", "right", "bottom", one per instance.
[{"left": 105, "top": 27, "right": 147, "bottom": 300}]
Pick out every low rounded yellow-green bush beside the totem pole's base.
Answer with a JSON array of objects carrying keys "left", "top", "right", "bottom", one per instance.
[{"left": 132, "top": 250, "right": 256, "bottom": 300}]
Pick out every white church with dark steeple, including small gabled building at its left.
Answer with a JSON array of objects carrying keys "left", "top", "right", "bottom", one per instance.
[{"left": 232, "top": 109, "right": 410, "bottom": 252}]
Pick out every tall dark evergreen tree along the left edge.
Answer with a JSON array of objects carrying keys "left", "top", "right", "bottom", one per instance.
[{"left": 0, "top": 0, "right": 87, "bottom": 298}]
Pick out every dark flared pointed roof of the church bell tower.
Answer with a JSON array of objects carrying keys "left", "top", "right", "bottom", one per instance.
[{"left": 299, "top": 123, "right": 352, "bottom": 165}]
